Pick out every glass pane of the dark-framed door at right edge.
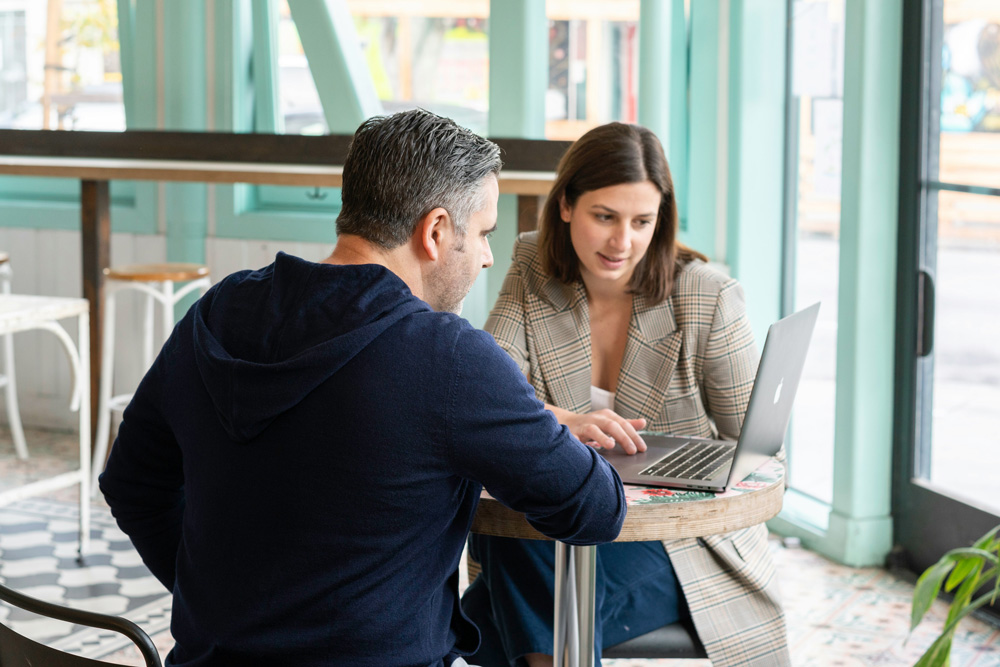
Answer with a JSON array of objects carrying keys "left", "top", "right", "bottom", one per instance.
[{"left": 918, "top": 0, "right": 1000, "bottom": 513}]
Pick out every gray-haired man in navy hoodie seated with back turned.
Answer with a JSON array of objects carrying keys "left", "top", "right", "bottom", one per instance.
[{"left": 101, "top": 110, "right": 625, "bottom": 667}]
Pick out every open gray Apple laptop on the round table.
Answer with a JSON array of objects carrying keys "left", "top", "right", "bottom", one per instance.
[{"left": 599, "top": 303, "right": 819, "bottom": 492}]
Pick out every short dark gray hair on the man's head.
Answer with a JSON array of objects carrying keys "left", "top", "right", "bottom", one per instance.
[{"left": 337, "top": 109, "right": 501, "bottom": 250}]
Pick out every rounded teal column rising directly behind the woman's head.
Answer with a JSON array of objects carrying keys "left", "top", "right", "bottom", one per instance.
[{"left": 639, "top": 0, "right": 688, "bottom": 228}]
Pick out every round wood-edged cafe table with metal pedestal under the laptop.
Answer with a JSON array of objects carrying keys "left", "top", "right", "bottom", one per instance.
[{"left": 472, "top": 459, "right": 785, "bottom": 667}]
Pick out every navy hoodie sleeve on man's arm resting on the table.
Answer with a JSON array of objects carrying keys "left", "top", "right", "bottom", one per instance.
[{"left": 447, "top": 329, "right": 626, "bottom": 545}]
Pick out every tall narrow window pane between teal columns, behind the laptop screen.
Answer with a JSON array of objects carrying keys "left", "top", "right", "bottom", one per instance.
[{"left": 785, "top": 0, "right": 844, "bottom": 503}]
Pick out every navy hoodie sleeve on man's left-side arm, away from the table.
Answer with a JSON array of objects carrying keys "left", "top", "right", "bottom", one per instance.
[{"left": 100, "top": 346, "right": 184, "bottom": 590}]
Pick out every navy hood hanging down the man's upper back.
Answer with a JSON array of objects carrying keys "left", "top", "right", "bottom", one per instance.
[{"left": 193, "top": 252, "right": 431, "bottom": 442}]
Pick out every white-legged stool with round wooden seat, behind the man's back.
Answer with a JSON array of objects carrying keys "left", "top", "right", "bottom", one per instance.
[{"left": 91, "top": 263, "right": 212, "bottom": 494}]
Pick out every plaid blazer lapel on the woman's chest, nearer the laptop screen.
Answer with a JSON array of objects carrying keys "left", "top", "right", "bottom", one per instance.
[{"left": 615, "top": 295, "right": 683, "bottom": 420}]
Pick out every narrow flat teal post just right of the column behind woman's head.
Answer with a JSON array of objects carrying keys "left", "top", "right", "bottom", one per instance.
[{"left": 679, "top": 0, "right": 725, "bottom": 261}]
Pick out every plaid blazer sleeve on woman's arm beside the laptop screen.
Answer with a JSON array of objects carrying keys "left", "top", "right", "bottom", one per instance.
[{"left": 702, "top": 280, "right": 757, "bottom": 440}]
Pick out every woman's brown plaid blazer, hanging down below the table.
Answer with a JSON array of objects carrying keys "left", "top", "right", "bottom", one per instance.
[{"left": 484, "top": 232, "right": 791, "bottom": 667}]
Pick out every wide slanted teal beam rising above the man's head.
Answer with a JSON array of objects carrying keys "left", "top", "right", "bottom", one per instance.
[{"left": 288, "top": 0, "right": 383, "bottom": 134}]
